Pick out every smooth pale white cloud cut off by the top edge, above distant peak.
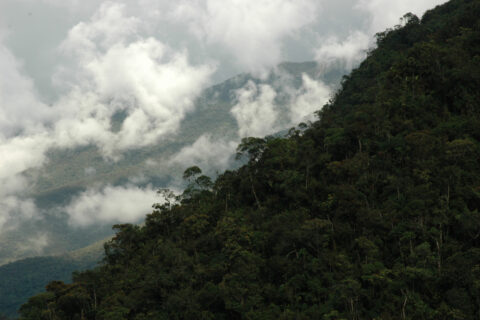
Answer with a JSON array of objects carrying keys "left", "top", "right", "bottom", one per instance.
[{"left": 171, "top": 0, "right": 320, "bottom": 72}]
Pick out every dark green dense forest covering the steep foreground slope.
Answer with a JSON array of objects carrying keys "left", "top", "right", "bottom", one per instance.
[{"left": 20, "top": 0, "right": 480, "bottom": 319}]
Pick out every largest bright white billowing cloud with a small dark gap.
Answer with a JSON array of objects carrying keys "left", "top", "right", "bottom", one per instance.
[{"left": 50, "top": 2, "right": 214, "bottom": 156}]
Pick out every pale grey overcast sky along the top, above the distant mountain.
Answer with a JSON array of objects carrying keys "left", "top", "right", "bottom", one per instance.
[{"left": 0, "top": 0, "right": 445, "bottom": 102}]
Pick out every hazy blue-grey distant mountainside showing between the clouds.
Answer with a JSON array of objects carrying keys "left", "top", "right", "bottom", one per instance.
[{"left": 0, "top": 62, "right": 345, "bottom": 265}]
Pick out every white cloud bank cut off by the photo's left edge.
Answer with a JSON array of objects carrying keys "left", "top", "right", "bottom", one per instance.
[{"left": 0, "top": 43, "right": 54, "bottom": 229}]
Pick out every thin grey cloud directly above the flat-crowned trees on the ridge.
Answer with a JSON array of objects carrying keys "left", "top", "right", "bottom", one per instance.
[{"left": 169, "top": 134, "right": 237, "bottom": 174}]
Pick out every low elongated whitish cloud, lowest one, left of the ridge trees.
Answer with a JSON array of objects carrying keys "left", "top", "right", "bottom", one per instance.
[{"left": 62, "top": 185, "right": 158, "bottom": 227}]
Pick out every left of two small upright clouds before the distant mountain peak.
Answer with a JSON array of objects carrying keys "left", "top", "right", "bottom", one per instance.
[{"left": 231, "top": 81, "right": 279, "bottom": 137}]
